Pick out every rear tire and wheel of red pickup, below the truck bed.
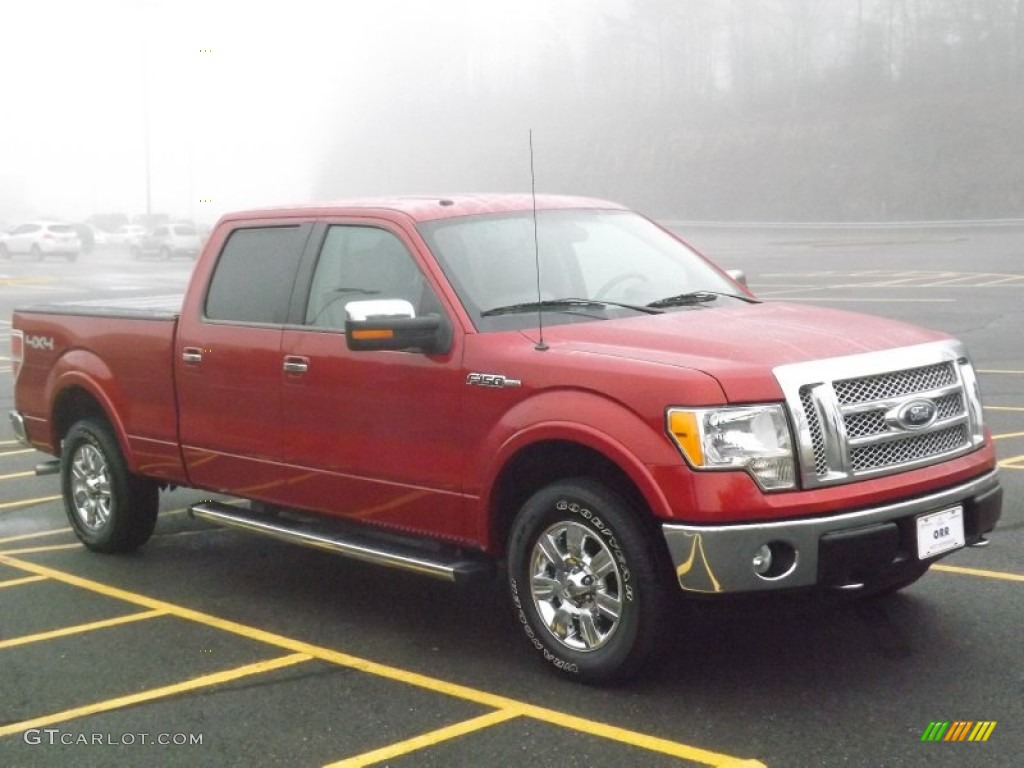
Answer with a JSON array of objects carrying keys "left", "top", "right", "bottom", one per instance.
[{"left": 60, "top": 418, "right": 159, "bottom": 552}]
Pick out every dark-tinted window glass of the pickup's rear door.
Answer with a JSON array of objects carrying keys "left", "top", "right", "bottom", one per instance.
[{"left": 205, "top": 226, "right": 305, "bottom": 325}]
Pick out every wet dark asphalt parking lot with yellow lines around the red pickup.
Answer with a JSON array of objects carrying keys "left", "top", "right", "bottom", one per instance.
[{"left": 0, "top": 234, "right": 1024, "bottom": 768}]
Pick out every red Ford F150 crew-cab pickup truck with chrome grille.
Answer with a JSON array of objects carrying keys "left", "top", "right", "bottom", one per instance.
[{"left": 11, "top": 196, "right": 1001, "bottom": 681}]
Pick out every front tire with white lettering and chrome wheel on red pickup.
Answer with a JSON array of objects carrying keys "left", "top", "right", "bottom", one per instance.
[{"left": 508, "top": 478, "right": 668, "bottom": 683}]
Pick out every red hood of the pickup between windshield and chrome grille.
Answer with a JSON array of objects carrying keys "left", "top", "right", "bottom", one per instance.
[{"left": 545, "top": 303, "right": 948, "bottom": 402}]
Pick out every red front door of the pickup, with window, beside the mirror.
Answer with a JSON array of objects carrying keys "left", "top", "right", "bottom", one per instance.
[{"left": 282, "top": 218, "right": 476, "bottom": 539}]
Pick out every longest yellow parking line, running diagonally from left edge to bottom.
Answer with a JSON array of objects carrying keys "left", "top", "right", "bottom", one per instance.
[{"left": 0, "top": 554, "right": 763, "bottom": 768}]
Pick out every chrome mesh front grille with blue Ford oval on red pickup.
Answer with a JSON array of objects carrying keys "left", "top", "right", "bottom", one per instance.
[{"left": 775, "top": 341, "right": 984, "bottom": 487}]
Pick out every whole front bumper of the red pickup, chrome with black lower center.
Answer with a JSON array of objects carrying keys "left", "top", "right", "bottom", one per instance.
[{"left": 663, "top": 471, "right": 1002, "bottom": 594}]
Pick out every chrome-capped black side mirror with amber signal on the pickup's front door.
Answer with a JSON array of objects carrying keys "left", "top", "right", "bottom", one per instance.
[{"left": 345, "top": 299, "right": 452, "bottom": 354}]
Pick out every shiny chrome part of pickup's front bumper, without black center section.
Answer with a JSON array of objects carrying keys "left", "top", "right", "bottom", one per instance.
[{"left": 663, "top": 471, "right": 999, "bottom": 594}]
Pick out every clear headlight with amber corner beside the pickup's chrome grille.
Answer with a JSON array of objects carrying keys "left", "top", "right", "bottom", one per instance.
[{"left": 666, "top": 406, "right": 797, "bottom": 490}]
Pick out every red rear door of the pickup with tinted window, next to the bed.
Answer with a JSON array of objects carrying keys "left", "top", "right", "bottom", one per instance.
[{"left": 175, "top": 221, "right": 310, "bottom": 498}]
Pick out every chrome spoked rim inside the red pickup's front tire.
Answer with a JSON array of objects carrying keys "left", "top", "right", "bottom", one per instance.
[{"left": 529, "top": 520, "right": 623, "bottom": 651}]
